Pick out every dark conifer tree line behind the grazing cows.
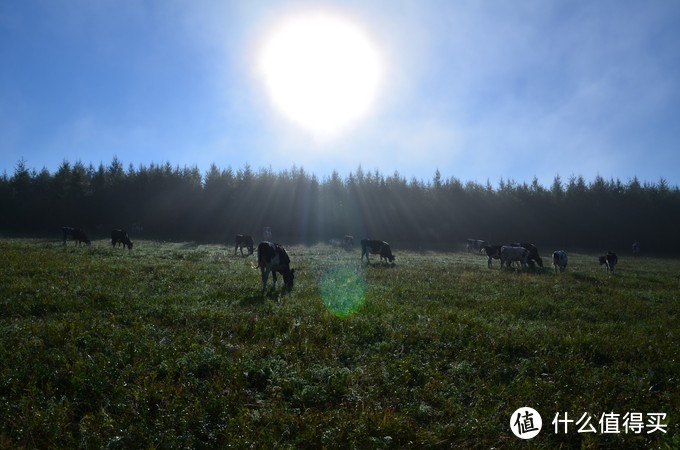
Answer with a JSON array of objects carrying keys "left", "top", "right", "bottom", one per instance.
[{"left": 0, "top": 158, "right": 680, "bottom": 254}]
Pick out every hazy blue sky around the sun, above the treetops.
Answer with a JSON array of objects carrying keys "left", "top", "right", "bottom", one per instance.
[{"left": 0, "top": 0, "right": 680, "bottom": 186}]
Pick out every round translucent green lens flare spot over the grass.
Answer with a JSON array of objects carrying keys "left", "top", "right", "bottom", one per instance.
[{"left": 319, "top": 268, "right": 366, "bottom": 317}]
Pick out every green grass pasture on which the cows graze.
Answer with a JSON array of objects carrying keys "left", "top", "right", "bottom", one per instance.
[{"left": 0, "top": 239, "right": 680, "bottom": 448}]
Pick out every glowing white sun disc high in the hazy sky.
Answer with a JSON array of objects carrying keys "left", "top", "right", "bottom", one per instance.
[{"left": 258, "top": 12, "right": 382, "bottom": 136}]
